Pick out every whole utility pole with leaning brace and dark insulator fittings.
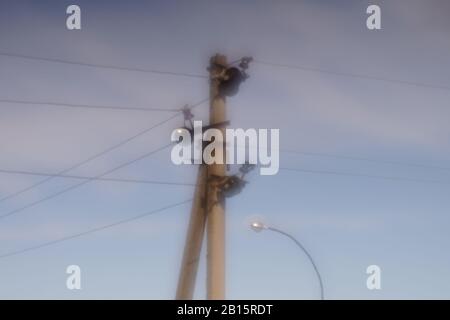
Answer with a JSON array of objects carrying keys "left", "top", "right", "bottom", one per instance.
[{"left": 176, "top": 54, "right": 252, "bottom": 300}]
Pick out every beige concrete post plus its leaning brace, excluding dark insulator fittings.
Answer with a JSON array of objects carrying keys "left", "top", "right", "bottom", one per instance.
[{"left": 176, "top": 55, "right": 227, "bottom": 300}]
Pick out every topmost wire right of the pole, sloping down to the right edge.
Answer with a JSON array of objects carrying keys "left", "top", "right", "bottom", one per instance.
[{"left": 255, "top": 60, "right": 450, "bottom": 91}]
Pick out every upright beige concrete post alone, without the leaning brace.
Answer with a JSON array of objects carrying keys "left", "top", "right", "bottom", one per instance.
[{"left": 207, "top": 55, "right": 227, "bottom": 299}]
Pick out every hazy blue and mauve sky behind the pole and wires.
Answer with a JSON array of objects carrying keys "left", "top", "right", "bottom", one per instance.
[{"left": 0, "top": 0, "right": 450, "bottom": 299}]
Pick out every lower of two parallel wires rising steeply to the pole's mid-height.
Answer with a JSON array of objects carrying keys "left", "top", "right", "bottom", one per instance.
[{"left": 0, "top": 143, "right": 173, "bottom": 219}]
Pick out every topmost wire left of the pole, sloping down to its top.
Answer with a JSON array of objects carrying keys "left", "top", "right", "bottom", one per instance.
[{"left": 0, "top": 52, "right": 207, "bottom": 79}]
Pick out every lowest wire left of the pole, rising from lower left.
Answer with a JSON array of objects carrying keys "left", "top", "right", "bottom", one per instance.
[{"left": 0, "top": 199, "right": 192, "bottom": 259}]
